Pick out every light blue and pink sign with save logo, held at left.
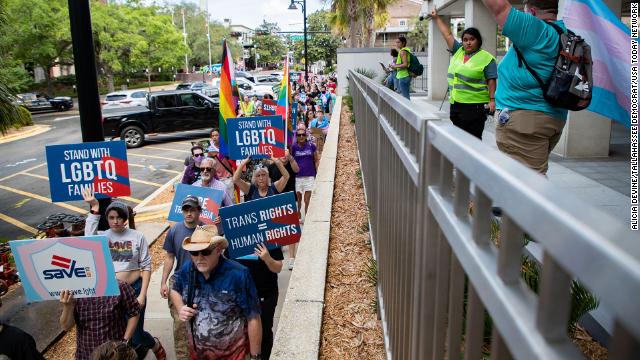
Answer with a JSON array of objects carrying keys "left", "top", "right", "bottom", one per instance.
[{"left": 9, "top": 236, "right": 120, "bottom": 301}]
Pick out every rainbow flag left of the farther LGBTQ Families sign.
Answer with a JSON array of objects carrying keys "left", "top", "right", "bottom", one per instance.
[{"left": 218, "top": 39, "right": 238, "bottom": 156}]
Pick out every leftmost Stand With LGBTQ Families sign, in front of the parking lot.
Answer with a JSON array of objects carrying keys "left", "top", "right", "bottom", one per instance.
[{"left": 46, "top": 141, "right": 131, "bottom": 202}]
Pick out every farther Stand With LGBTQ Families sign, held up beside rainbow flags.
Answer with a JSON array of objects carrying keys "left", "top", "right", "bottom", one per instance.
[{"left": 227, "top": 115, "right": 285, "bottom": 160}]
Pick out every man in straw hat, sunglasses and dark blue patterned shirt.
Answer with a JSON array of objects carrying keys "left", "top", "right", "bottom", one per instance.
[{"left": 171, "top": 225, "right": 262, "bottom": 360}]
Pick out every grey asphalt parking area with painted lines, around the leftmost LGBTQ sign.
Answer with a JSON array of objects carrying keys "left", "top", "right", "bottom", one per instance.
[{"left": 0, "top": 111, "right": 208, "bottom": 240}]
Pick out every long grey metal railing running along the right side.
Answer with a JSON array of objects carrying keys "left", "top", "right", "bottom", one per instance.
[{"left": 349, "top": 71, "right": 640, "bottom": 359}]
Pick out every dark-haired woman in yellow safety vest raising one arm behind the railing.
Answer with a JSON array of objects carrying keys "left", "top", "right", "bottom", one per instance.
[{"left": 431, "top": 9, "right": 498, "bottom": 139}]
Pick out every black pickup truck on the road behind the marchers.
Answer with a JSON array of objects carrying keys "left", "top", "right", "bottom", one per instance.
[{"left": 102, "top": 90, "right": 220, "bottom": 148}]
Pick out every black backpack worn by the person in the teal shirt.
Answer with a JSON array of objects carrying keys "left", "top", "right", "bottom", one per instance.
[{"left": 513, "top": 23, "right": 593, "bottom": 111}]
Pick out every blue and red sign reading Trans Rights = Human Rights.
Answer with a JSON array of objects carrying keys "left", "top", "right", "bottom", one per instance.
[{"left": 220, "top": 192, "right": 301, "bottom": 259}]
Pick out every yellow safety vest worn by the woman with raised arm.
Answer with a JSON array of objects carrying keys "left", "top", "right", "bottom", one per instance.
[{"left": 447, "top": 46, "right": 495, "bottom": 104}]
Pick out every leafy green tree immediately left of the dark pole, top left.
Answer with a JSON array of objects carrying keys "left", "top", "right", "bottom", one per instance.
[{"left": 5, "top": 0, "right": 73, "bottom": 94}]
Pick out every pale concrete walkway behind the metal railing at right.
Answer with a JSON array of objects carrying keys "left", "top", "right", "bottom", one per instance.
[{"left": 411, "top": 97, "right": 631, "bottom": 224}]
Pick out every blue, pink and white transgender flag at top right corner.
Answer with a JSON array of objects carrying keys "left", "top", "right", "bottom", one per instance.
[{"left": 562, "top": 0, "right": 631, "bottom": 128}]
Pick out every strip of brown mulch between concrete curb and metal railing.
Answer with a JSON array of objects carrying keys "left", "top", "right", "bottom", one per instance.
[{"left": 320, "top": 100, "right": 385, "bottom": 360}]
